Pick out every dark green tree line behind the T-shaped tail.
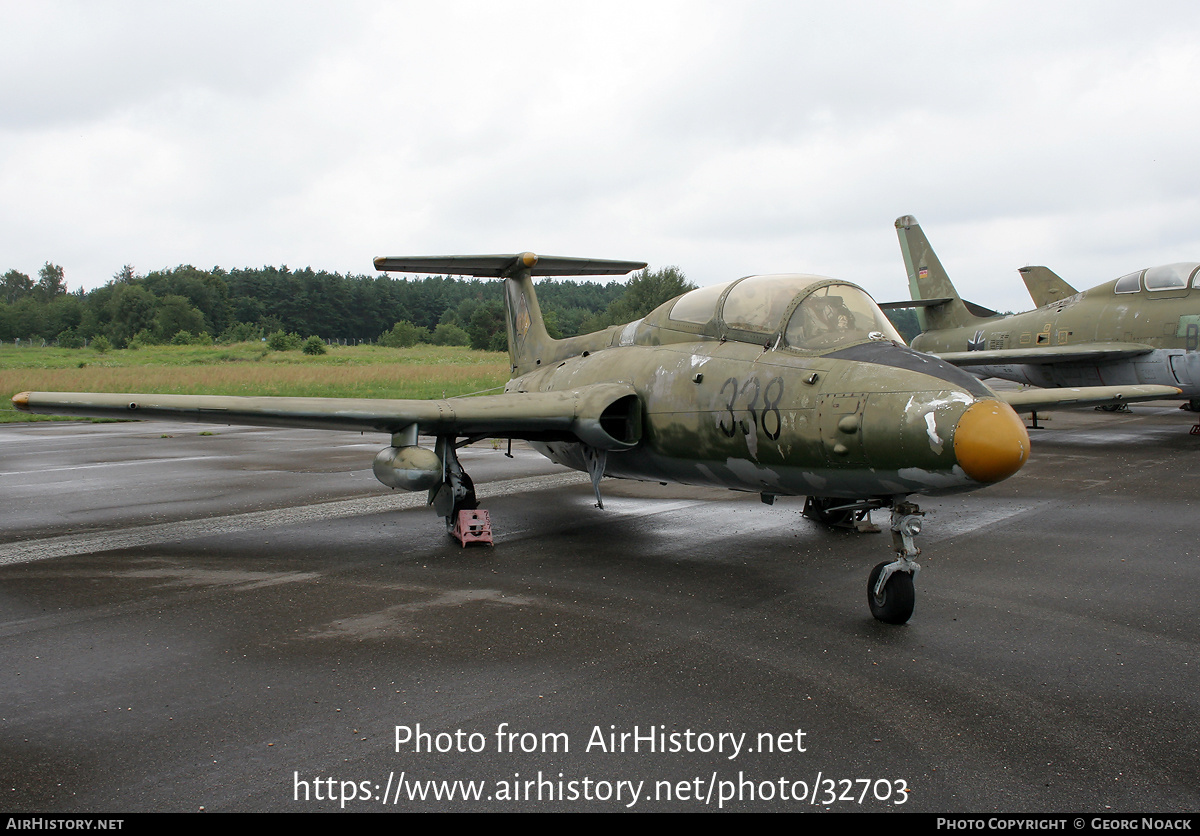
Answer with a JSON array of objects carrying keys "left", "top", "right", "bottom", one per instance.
[{"left": 0, "top": 263, "right": 694, "bottom": 350}]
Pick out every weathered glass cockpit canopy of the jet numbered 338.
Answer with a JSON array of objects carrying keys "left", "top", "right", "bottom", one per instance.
[{"left": 670, "top": 273, "right": 904, "bottom": 351}]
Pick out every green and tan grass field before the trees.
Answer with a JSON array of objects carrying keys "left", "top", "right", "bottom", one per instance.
[{"left": 0, "top": 343, "right": 509, "bottom": 423}]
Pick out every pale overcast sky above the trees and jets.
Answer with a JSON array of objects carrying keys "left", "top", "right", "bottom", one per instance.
[{"left": 0, "top": 0, "right": 1200, "bottom": 311}]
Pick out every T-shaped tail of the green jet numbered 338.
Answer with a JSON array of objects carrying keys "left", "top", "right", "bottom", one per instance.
[{"left": 374, "top": 252, "right": 646, "bottom": 375}]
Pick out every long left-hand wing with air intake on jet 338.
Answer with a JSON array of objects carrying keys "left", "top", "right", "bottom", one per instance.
[{"left": 12, "top": 383, "right": 642, "bottom": 450}]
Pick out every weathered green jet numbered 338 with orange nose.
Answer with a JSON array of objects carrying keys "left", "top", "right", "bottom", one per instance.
[{"left": 13, "top": 253, "right": 1070, "bottom": 624}]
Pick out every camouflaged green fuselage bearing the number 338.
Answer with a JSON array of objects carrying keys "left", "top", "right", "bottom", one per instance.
[{"left": 506, "top": 289, "right": 1028, "bottom": 498}]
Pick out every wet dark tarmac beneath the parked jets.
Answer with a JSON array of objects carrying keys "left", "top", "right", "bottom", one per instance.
[{"left": 0, "top": 404, "right": 1200, "bottom": 813}]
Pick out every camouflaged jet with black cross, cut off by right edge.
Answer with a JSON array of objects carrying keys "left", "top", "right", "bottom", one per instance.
[{"left": 889, "top": 215, "right": 1200, "bottom": 408}]
